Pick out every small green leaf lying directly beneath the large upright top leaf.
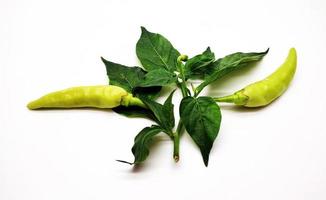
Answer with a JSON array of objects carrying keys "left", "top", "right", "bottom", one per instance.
[{"left": 137, "top": 69, "right": 177, "bottom": 87}]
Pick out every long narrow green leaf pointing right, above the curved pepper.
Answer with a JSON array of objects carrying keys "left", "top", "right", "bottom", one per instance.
[{"left": 196, "top": 49, "right": 269, "bottom": 95}]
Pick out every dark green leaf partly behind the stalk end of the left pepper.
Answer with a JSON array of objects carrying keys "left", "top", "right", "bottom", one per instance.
[{"left": 102, "top": 58, "right": 161, "bottom": 98}]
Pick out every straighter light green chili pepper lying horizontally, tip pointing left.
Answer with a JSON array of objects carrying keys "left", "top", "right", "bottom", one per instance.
[{"left": 27, "top": 85, "right": 146, "bottom": 110}]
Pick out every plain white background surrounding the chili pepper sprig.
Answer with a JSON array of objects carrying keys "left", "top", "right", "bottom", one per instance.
[{"left": 0, "top": 0, "right": 326, "bottom": 200}]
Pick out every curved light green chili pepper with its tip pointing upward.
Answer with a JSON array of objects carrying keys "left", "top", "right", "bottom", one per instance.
[{"left": 214, "top": 48, "right": 297, "bottom": 107}]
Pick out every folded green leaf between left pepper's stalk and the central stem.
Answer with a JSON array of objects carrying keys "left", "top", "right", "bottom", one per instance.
[{"left": 139, "top": 92, "right": 175, "bottom": 135}]
